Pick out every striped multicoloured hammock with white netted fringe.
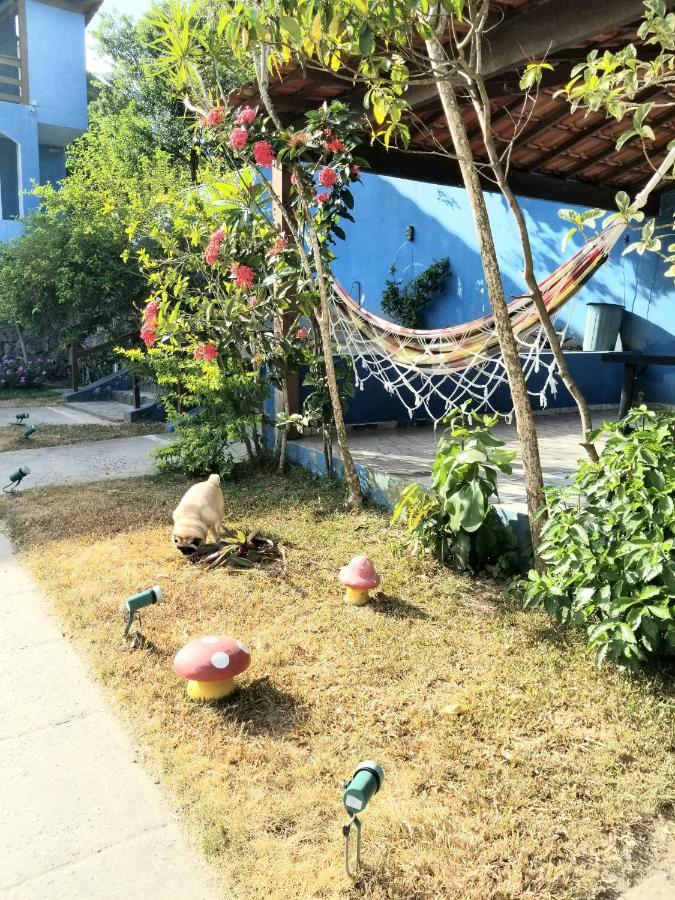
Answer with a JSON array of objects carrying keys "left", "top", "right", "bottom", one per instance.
[{"left": 331, "top": 222, "right": 625, "bottom": 422}]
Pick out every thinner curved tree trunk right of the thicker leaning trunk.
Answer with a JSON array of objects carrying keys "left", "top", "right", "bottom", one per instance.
[{"left": 474, "top": 76, "right": 599, "bottom": 462}]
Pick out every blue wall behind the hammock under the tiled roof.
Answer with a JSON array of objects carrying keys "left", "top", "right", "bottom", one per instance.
[{"left": 334, "top": 175, "right": 675, "bottom": 421}]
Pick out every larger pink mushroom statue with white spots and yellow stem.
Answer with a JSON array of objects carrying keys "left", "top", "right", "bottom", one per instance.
[{"left": 173, "top": 635, "right": 251, "bottom": 700}]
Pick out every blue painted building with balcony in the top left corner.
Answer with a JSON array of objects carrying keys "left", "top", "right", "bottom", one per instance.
[{"left": 0, "top": 0, "right": 101, "bottom": 240}]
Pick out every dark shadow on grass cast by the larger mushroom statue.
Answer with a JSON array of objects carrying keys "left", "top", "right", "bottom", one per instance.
[{"left": 217, "top": 675, "right": 306, "bottom": 735}]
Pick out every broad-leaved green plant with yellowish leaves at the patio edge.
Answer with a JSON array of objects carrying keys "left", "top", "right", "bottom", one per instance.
[{"left": 392, "top": 404, "right": 518, "bottom": 574}]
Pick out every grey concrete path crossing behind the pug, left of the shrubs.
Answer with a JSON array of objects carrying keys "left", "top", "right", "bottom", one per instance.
[{"left": 0, "top": 434, "right": 173, "bottom": 490}]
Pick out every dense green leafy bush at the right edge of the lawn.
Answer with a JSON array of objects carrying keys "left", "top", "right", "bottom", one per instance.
[{"left": 525, "top": 406, "right": 675, "bottom": 669}]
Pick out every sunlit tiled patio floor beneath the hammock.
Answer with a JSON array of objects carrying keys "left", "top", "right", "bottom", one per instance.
[{"left": 300, "top": 409, "right": 616, "bottom": 512}]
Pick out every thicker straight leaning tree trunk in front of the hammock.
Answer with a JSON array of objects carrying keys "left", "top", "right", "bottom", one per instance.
[{"left": 426, "top": 38, "right": 545, "bottom": 567}]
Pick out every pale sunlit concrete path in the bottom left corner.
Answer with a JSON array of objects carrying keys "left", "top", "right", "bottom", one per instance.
[{"left": 0, "top": 535, "right": 224, "bottom": 900}]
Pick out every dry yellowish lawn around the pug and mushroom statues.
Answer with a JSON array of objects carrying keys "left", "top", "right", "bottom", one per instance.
[{"left": 0, "top": 474, "right": 675, "bottom": 900}]
